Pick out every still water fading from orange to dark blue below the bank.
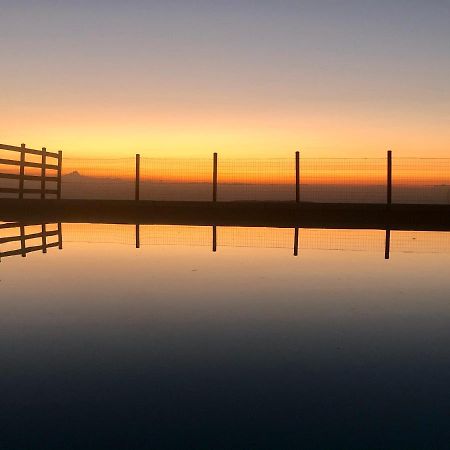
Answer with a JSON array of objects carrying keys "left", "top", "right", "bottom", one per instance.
[{"left": 0, "top": 224, "right": 450, "bottom": 450}]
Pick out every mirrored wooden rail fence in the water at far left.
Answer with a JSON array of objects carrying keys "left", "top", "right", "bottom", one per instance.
[{"left": 0, "top": 222, "right": 62, "bottom": 259}]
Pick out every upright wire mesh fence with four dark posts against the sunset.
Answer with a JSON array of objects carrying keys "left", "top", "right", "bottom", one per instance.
[{"left": 57, "top": 153, "right": 450, "bottom": 204}]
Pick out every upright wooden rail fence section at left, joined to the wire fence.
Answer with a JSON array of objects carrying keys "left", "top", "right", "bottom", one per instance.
[{"left": 0, "top": 144, "right": 62, "bottom": 199}]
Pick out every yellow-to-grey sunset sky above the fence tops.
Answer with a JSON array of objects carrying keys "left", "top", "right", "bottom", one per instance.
[{"left": 0, "top": 0, "right": 450, "bottom": 157}]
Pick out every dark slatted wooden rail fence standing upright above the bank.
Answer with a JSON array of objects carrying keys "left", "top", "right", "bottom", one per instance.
[{"left": 0, "top": 144, "right": 62, "bottom": 199}]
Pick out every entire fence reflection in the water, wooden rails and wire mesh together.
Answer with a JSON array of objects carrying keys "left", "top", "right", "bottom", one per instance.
[{"left": 0, "top": 222, "right": 450, "bottom": 260}]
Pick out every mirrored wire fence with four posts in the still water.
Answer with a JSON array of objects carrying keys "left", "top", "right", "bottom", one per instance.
[{"left": 60, "top": 224, "right": 450, "bottom": 258}]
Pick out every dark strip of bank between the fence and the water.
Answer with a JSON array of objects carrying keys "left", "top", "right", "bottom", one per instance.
[{"left": 0, "top": 199, "right": 450, "bottom": 231}]
